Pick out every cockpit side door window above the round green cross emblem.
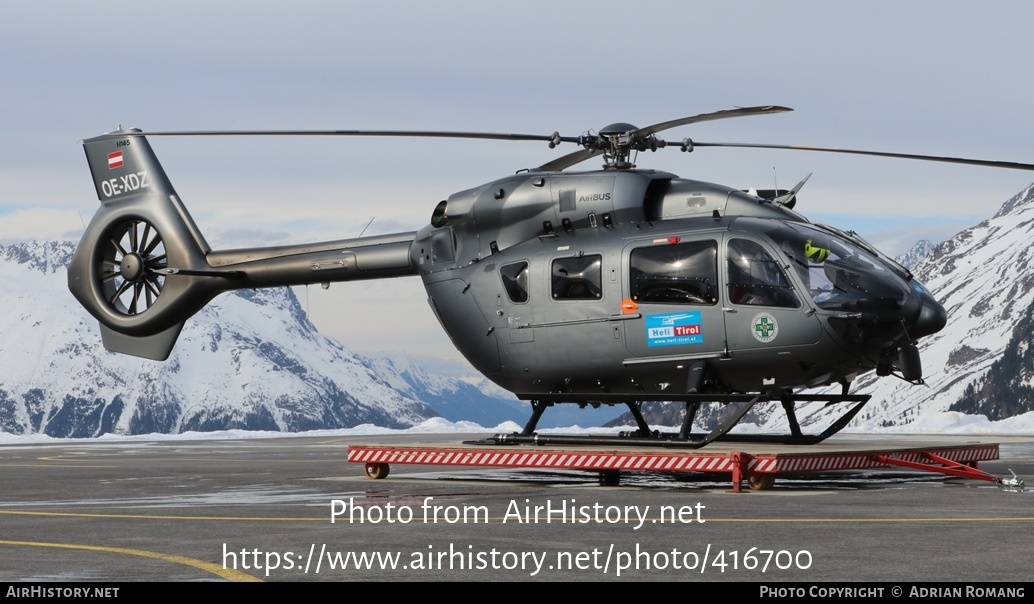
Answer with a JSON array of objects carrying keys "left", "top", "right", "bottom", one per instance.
[{"left": 728, "top": 239, "right": 800, "bottom": 308}]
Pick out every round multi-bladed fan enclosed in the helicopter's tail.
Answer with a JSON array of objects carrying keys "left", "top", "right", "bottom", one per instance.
[{"left": 96, "top": 219, "right": 169, "bottom": 316}]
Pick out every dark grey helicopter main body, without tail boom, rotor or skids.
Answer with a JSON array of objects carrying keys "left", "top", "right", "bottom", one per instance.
[{"left": 410, "top": 170, "right": 944, "bottom": 401}]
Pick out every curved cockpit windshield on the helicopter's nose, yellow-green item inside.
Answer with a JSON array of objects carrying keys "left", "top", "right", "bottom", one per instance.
[{"left": 766, "top": 222, "right": 909, "bottom": 312}]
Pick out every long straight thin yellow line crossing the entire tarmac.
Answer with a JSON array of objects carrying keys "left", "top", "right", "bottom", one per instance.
[{"left": 0, "top": 510, "right": 1034, "bottom": 525}]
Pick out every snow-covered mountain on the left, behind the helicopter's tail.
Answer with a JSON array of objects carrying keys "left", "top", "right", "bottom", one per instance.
[{"left": 0, "top": 242, "right": 436, "bottom": 436}]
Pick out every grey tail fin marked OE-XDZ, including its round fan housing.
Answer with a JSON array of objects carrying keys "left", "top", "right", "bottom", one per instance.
[{"left": 68, "top": 129, "right": 219, "bottom": 360}]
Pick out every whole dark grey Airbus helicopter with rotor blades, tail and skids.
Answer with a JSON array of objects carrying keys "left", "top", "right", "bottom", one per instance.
[{"left": 68, "top": 105, "right": 1034, "bottom": 448}]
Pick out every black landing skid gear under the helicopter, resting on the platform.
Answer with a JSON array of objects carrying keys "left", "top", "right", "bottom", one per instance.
[{"left": 469, "top": 394, "right": 871, "bottom": 449}]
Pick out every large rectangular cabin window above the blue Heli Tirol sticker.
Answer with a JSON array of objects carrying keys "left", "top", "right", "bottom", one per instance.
[{"left": 629, "top": 241, "right": 718, "bottom": 305}]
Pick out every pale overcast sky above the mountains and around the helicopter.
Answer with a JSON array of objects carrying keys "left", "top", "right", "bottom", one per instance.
[{"left": 0, "top": 0, "right": 1034, "bottom": 361}]
